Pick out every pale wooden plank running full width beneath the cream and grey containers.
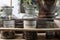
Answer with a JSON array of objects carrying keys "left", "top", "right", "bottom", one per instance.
[{"left": 0, "top": 28, "right": 60, "bottom": 32}]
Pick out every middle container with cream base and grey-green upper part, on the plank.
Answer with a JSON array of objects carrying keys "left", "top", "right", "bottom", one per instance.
[{"left": 23, "top": 5, "right": 37, "bottom": 28}]
